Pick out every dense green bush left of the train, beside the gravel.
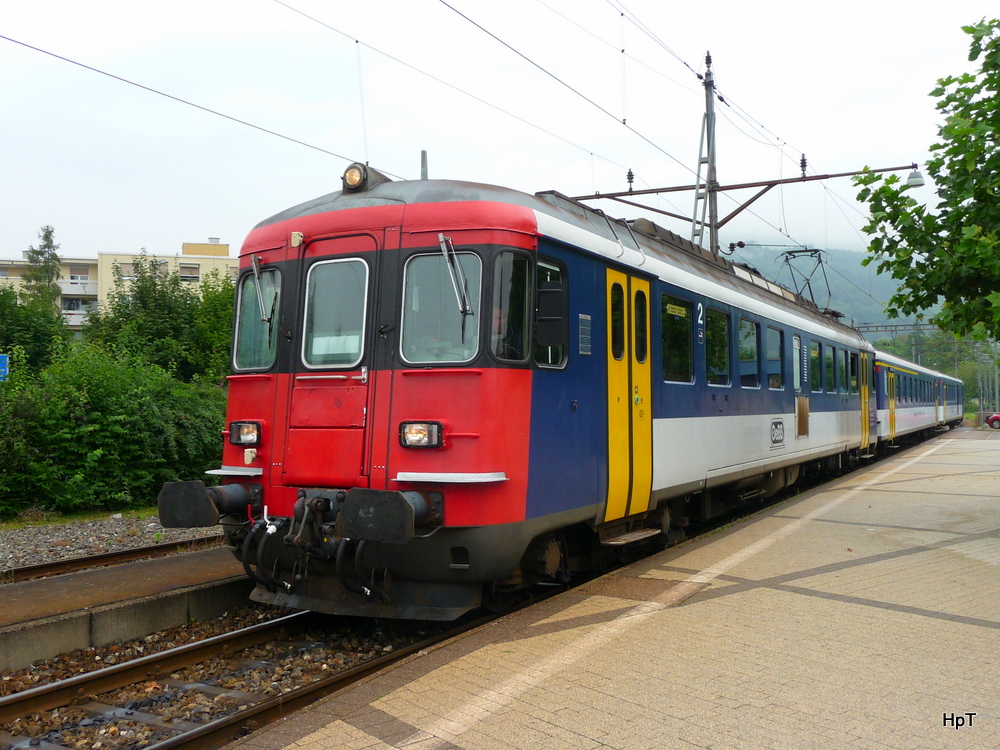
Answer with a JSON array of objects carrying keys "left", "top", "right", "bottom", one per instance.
[{"left": 0, "top": 343, "right": 225, "bottom": 517}]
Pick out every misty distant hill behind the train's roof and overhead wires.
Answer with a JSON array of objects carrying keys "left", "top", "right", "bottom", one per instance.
[{"left": 728, "top": 246, "right": 910, "bottom": 325}]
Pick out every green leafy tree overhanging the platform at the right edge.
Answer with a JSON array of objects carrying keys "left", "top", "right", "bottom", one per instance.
[{"left": 855, "top": 19, "right": 1000, "bottom": 338}]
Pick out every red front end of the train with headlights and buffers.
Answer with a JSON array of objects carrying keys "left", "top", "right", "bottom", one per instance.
[{"left": 159, "top": 165, "right": 572, "bottom": 619}]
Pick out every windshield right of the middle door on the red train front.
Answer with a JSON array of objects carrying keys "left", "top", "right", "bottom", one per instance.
[{"left": 400, "top": 252, "right": 482, "bottom": 363}]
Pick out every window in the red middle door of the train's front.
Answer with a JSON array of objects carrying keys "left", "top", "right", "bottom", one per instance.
[{"left": 302, "top": 259, "right": 368, "bottom": 367}]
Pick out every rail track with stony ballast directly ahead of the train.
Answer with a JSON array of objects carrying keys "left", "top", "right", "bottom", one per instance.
[{"left": 0, "top": 612, "right": 497, "bottom": 750}]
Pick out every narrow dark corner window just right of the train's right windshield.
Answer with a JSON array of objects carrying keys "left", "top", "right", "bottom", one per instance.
[{"left": 487, "top": 252, "right": 531, "bottom": 362}]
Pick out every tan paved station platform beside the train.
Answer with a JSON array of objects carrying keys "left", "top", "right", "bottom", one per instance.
[{"left": 229, "top": 430, "right": 1000, "bottom": 750}]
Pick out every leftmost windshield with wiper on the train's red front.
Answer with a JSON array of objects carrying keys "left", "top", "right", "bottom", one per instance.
[{"left": 233, "top": 268, "right": 281, "bottom": 370}]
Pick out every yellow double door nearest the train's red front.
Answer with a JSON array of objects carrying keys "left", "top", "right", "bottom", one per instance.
[{"left": 598, "top": 268, "right": 653, "bottom": 522}]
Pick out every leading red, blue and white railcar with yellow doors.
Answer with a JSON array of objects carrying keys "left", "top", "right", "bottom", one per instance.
[{"left": 159, "top": 165, "right": 960, "bottom": 620}]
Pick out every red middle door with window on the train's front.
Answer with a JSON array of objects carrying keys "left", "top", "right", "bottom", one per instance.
[{"left": 282, "top": 234, "right": 377, "bottom": 494}]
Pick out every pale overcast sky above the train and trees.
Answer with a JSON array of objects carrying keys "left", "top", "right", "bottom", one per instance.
[{"left": 0, "top": 0, "right": 998, "bottom": 258}]
